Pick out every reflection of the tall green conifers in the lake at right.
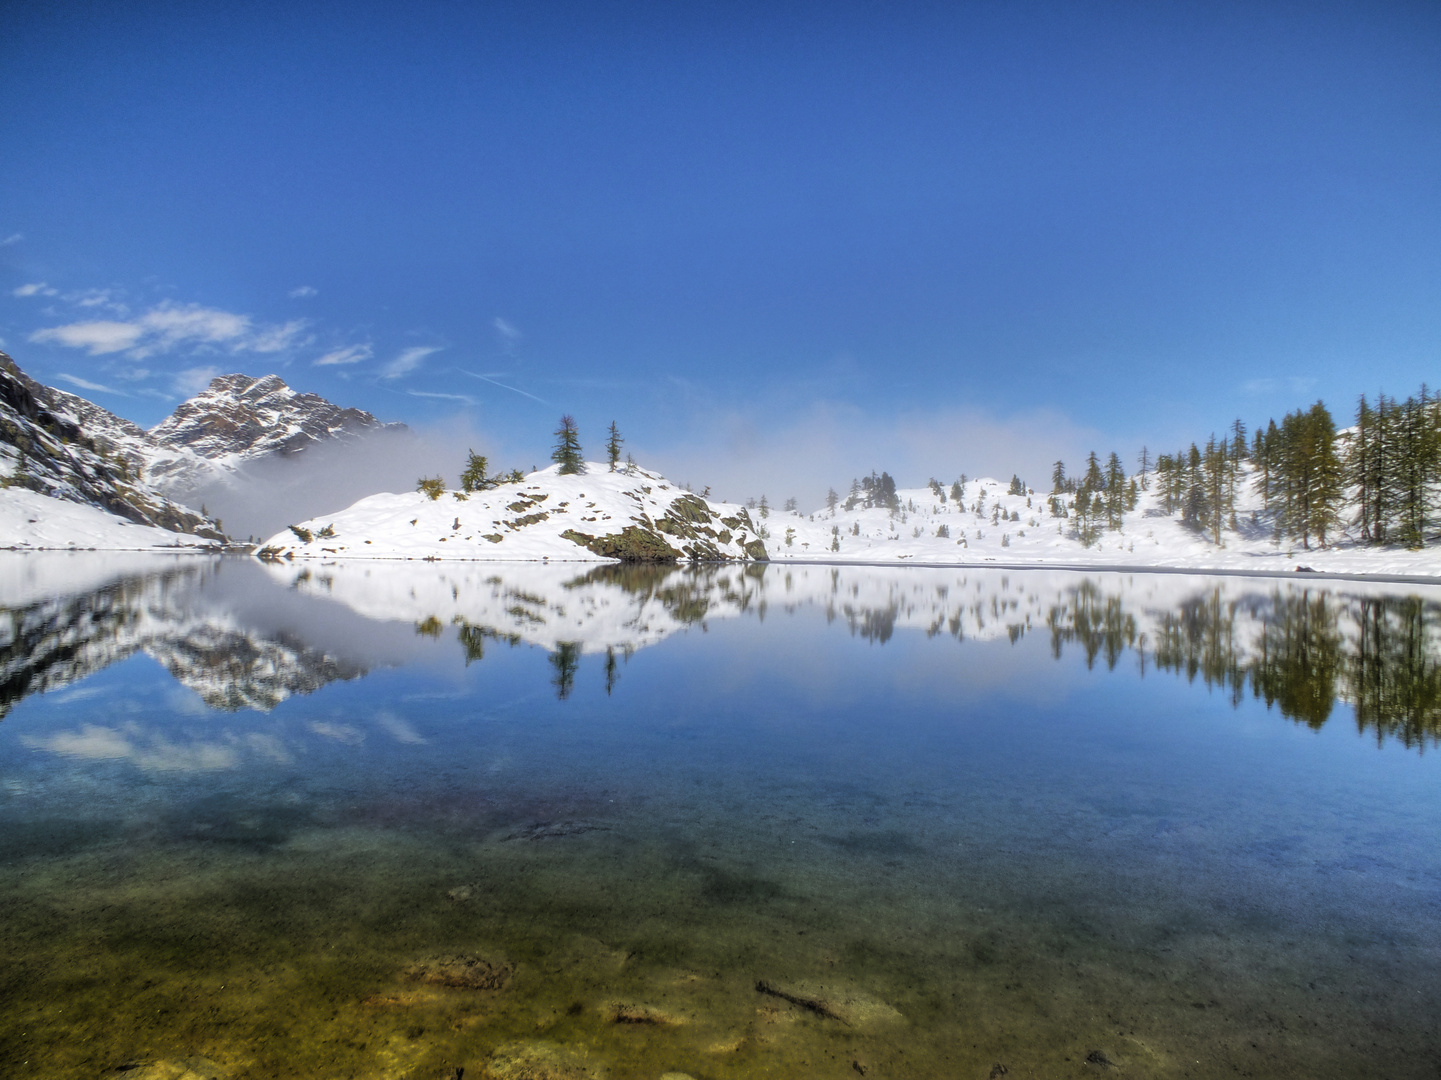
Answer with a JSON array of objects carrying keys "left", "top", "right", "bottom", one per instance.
[{"left": 1048, "top": 581, "right": 1441, "bottom": 747}]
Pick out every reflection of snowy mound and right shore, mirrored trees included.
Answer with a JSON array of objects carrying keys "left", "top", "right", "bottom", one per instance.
[{"left": 269, "top": 562, "right": 1441, "bottom": 745}]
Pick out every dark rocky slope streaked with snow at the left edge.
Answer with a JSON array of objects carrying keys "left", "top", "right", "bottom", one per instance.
[{"left": 0, "top": 353, "right": 225, "bottom": 541}]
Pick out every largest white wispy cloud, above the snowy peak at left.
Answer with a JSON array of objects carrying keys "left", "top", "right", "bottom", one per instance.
[{"left": 30, "top": 298, "right": 305, "bottom": 359}]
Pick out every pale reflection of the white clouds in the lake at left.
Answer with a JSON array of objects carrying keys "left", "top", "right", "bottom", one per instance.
[{"left": 20, "top": 724, "right": 294, "bottom": 773}]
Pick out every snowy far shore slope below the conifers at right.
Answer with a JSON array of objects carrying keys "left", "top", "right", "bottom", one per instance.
[{"left": 757, "top": 474, "right": 1441, "bottom": 577}]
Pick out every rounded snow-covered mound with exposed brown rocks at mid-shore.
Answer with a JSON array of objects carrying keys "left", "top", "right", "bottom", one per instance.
[{"left": 261, "top": 461, "right": 767, "bottom": 562}]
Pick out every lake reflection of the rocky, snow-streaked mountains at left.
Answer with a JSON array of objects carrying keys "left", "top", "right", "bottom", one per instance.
[{"left": 0, "top": 557, "right": 365, "bottom": 717}]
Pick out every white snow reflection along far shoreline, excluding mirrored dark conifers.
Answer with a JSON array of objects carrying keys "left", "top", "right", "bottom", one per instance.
[{"left": 259, "top": 559, "right": 1441, "bottom": 652}]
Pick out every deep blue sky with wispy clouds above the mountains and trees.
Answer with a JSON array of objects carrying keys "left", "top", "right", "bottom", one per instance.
[{"left": 0, "top": 3, "right": 1441, "bottom": 497}]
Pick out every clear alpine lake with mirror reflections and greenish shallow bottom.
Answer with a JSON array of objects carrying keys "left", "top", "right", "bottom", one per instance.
[{"left": 0, "top": 552, "right": 1441, "bottom": 1080}]
